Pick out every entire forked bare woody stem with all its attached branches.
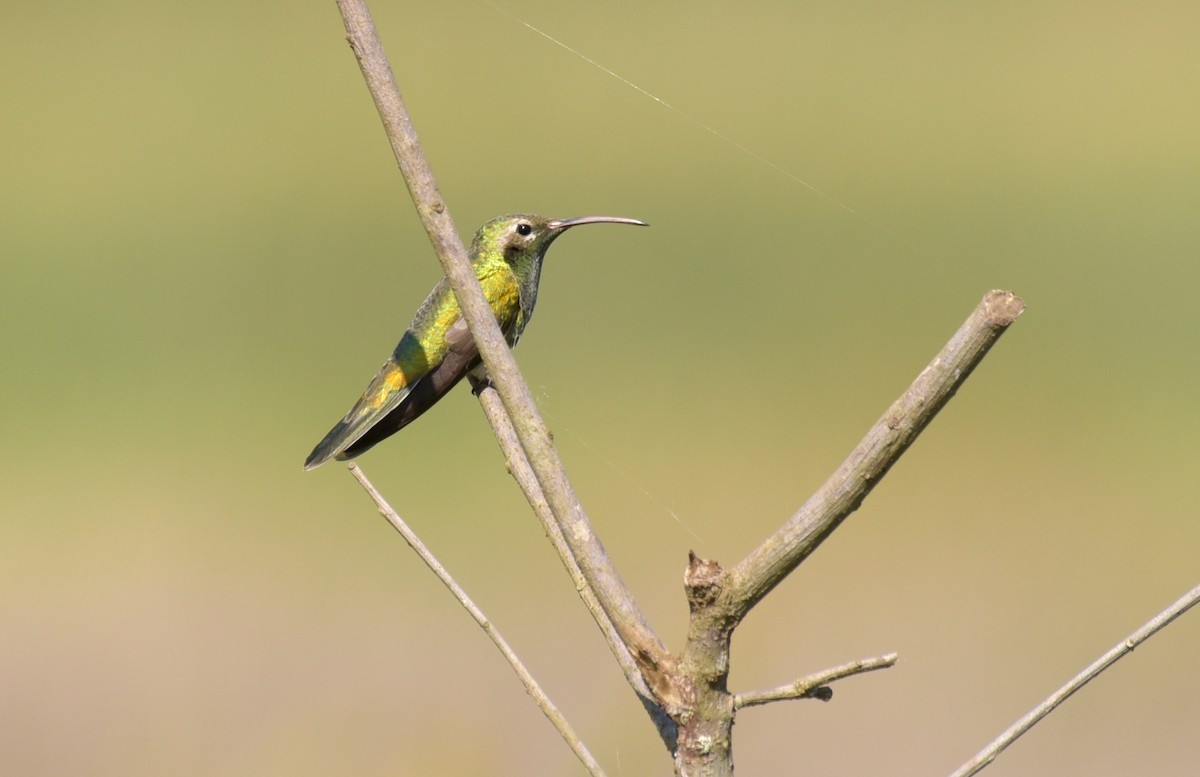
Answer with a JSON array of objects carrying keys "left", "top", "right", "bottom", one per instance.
[{"left": 337, "top": 7, "right": 1025, "bottom": 775}]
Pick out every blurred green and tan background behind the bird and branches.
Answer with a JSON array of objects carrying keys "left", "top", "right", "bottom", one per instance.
[{"left": 0, "top": 0, "right": 1200, "bottom": 776}]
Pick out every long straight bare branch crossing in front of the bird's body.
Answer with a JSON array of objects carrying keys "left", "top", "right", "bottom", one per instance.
[{"left": 337, "top": 0, "right": 668, "bottom": 667}]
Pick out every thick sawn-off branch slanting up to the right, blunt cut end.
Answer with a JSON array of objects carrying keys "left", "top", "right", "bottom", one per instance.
[{"left": 726, "top": 291, "right": 1025, "bottom": 622}]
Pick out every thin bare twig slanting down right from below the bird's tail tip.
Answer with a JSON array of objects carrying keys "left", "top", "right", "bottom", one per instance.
[{"left": 349, "top": 463, "right": 605, "bottom": 777}]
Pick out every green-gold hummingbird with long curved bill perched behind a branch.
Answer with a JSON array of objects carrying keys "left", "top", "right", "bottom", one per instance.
[{"left": 304, "top": 213, "right": 648, "bottom": 470}]
